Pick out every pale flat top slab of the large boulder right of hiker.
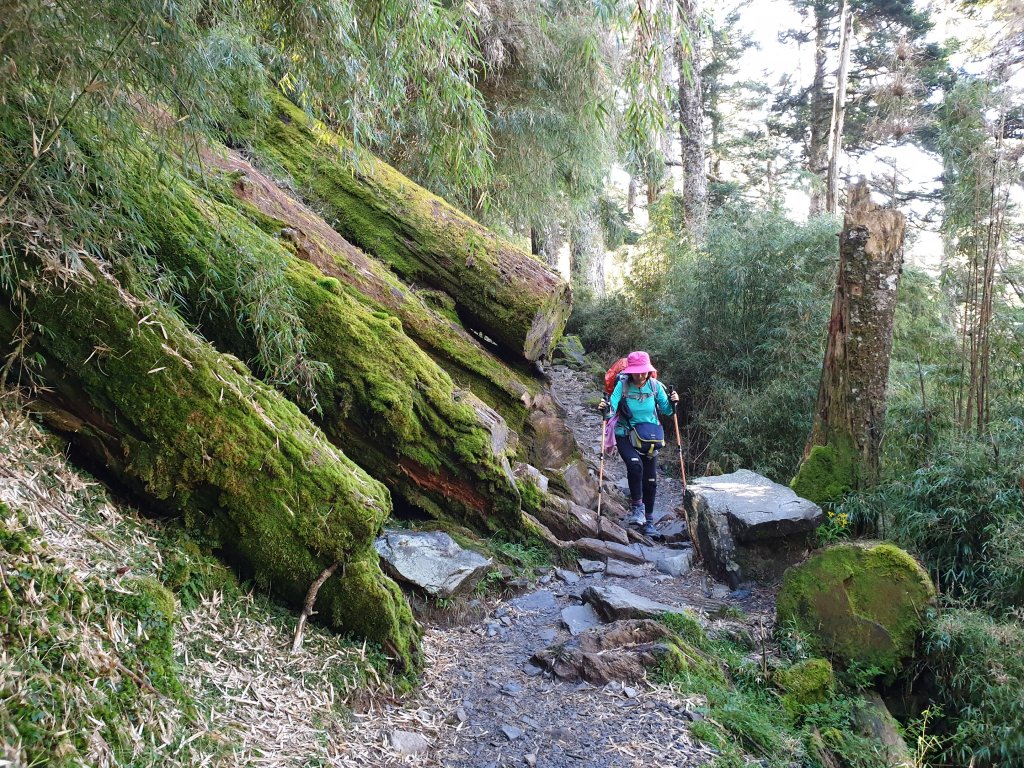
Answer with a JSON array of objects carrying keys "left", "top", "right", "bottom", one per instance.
[{"left": 690, "top": 469, "right": 822, "bottom": 543}]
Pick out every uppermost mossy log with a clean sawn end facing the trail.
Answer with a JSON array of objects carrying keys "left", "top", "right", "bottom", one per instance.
[{"left": 244, "top": 93, "right": 571, "bottom": 360}]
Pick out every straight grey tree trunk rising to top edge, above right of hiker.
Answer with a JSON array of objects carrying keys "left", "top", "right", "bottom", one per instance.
[{"left": 675, "top": 0, "right": 708, "bottom": 242}]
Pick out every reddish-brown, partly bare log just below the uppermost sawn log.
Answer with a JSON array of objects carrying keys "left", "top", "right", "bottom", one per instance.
[{"left": 206, "top": 150, "right": 538, "bottom": 432}]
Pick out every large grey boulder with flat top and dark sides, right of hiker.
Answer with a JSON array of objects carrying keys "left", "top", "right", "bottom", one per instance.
[{"left": 689, "top": 469, "right": 822, "bottom": 588}]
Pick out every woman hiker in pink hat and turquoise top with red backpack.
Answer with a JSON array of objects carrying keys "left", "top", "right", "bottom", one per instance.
[{"left": 599, "top": 352, "right": 679, "bottom": 536}]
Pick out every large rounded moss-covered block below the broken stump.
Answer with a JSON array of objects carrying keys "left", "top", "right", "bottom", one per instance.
[{"left": 777, "top": 543, "right": 935, "bottom": 676}]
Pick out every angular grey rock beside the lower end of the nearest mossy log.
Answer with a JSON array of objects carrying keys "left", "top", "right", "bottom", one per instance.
[{"left": 375, "top": 530, "right": 492, "bottom": 597}]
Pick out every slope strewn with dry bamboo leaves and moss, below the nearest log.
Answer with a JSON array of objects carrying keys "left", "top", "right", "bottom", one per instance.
[{"left": 0, "top": 401, "right": 386, "bottom": 768}]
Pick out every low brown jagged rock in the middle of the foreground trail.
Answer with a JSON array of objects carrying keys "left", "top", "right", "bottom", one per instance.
[{"left": 531, "top": 621, "right": 680, "bottom": 685}]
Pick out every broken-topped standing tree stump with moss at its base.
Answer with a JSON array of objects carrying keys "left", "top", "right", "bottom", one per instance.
[{"left": 792, "top": 181, "right": 906, "bottom": 504}]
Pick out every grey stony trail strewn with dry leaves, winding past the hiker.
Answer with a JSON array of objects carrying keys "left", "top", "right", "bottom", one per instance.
[{"left": 345, "top": 366, "right": 774, "bottom": 768}]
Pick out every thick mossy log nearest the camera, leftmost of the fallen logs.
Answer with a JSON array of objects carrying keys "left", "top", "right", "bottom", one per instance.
[{"left": 0, "top": 255, "right": 419, "bottom": 670}]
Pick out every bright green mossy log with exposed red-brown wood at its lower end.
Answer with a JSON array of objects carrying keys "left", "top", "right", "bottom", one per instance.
[{"left": 124, "top": 162, "right": 522, "bottom": 532}]
